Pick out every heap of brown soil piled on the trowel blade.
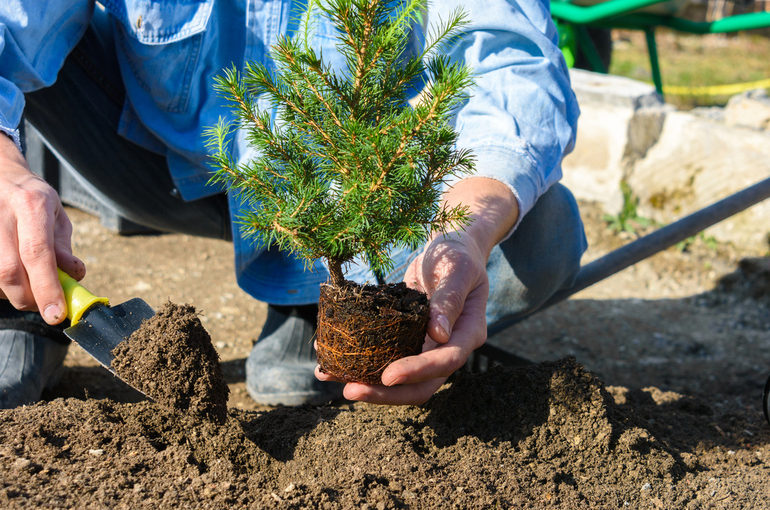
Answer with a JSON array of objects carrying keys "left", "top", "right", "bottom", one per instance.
[{"left": 112, "top": 301, "right": 229, "bottom": 423}]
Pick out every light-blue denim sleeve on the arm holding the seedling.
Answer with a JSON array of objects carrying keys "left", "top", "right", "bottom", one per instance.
[{"left": 428, "top": 0, "right": 579, "bottom": 235}]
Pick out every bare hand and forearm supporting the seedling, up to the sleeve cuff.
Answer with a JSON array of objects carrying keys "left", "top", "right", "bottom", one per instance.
[{"left": 315, "top": 177, "right": 519, "bottom": 405}]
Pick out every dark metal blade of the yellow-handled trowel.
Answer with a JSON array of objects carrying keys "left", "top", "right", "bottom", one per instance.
[{"left": 64, "top": 298, "right": 155, "bottom": 375}]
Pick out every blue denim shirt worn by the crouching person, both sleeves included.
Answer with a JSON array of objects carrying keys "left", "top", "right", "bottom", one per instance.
[{"left": 0, "top": 0, "right": 578, "bottom": 304}]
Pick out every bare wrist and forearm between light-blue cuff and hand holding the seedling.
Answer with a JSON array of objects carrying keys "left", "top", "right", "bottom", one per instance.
[{"left": 439, "top": 177, "right": 519, "bottom": 260}]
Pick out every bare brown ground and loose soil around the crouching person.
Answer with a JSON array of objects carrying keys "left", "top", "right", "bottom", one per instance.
[{"left": 0, "top": 204, "right": 770, "bottom": 509}]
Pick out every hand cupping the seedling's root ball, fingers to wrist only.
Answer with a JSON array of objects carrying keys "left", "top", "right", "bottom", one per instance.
[{"left": 316, "top": 232, "right": 489, "bottom": 405}]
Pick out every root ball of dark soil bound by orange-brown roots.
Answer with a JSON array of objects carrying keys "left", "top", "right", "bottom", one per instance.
[{"left": 316, "top": 281, "right": 430, "bottom": 384}]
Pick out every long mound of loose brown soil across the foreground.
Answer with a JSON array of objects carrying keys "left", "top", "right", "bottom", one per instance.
[{"left": 0, "top": 358, "right": 770, "bottom": 509}]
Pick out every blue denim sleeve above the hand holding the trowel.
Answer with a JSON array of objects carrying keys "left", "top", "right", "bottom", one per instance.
[{"left": 0, "top": 0, "right": 94, "bottom": 148}]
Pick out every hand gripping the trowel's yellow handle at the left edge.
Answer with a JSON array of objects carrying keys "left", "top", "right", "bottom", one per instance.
[{"left": 0, "top": 133, "right": 85, "bottom": 324}]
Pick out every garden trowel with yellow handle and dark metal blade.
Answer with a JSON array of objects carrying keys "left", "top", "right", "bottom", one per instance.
[{"left": 58, "top": 269, "right": 155, "bottom": 375}]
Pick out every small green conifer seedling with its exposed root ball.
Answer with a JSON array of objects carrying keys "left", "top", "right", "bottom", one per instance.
[{"left": 208, "top": 0, "right": 473, "bottom": 384}]
